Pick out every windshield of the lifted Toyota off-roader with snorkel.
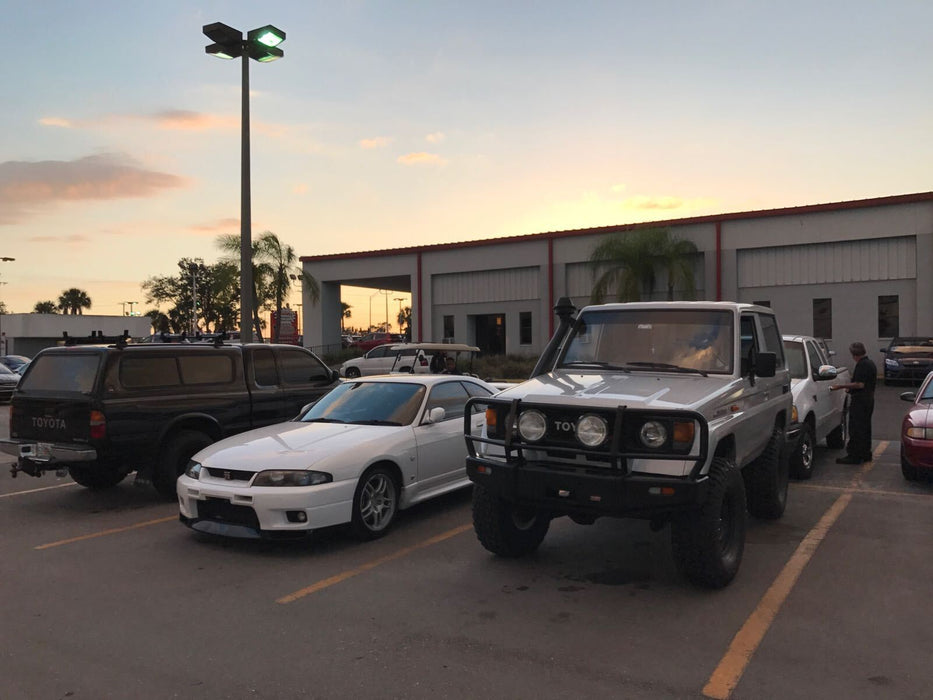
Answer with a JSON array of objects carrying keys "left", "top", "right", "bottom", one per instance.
[{"left": 558, "top": 309, "right": 734, "bottom": 374}]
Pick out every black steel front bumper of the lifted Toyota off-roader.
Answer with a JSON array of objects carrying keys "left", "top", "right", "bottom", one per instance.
[{"left": 466, "top": 457, "right": 709, "bottom": 518}]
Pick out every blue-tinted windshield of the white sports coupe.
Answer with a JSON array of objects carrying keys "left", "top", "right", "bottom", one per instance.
[{"left": 301, "top": 382, "right": 425, "bottom": 425}]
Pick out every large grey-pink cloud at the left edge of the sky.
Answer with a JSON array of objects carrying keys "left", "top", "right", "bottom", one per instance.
[{"left": 0, "top": 154, "right": 187, "bottom": 225}]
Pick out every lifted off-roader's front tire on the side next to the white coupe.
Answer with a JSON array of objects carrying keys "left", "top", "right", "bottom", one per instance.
[{"left": 473, "top": 485, "right": 551, "bottom": 558}]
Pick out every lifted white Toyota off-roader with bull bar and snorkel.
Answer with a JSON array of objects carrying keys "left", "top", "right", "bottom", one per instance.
[{"left": 464, "top": 299, "right": 792, "bottom": 588}]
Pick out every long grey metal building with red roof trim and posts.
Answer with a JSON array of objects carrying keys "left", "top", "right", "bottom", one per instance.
[{"left": 301, "top": 192, "right": 933, "bottom": 357}]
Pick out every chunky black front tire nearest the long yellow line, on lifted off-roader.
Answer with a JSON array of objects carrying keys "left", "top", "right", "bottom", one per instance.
[{"left": 671, "top": 457, "right": 748, "bottom": 588}]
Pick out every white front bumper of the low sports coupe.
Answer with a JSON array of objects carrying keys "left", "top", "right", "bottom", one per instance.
[{"left": 176, "top": 472, "right": 356, "bottom": 538}]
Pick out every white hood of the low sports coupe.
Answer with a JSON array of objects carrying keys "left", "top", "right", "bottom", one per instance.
[{"left": 193, "top": 422, "right": 400, "bottom": 472}]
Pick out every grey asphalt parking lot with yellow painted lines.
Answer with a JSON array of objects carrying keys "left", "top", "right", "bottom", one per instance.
[{"left": 0, "top": 386, "right": 933, "bottom": 699}]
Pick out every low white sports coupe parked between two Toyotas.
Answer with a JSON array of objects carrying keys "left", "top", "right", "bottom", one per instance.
[{"left": 183, "top": 374, "right": 495, "bottom": 539}]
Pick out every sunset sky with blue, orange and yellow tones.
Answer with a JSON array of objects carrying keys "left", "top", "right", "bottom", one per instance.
[{"left": 0, "top": 0, "right": 933, "bottom": 325}]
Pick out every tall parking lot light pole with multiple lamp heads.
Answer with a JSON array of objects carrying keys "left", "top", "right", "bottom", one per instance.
[{"left": 202, "top": 22, "right": 285, "bottom": 343}]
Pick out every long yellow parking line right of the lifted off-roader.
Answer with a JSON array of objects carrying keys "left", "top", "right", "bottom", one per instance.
[{"left": 703, "top": 441, "right": 888, "bottom": 700}]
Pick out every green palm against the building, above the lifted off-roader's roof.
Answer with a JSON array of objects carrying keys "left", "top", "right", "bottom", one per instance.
[{"left": 590, "top": 228, "right": 697, "bottom": 304}]
